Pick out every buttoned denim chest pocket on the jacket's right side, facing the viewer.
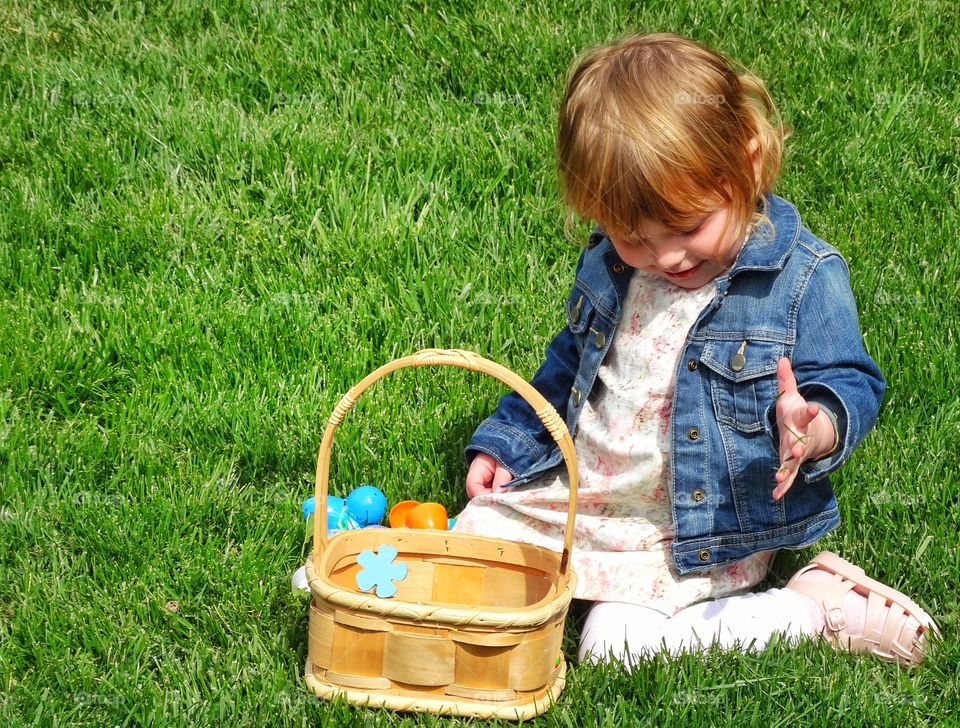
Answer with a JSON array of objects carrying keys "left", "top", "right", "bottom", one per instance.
[{"left": 700, "top": 339, "right": 785, "bottom": 432}]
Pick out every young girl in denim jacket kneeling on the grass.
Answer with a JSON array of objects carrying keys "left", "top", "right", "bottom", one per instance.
[{"left": 456, "top": 34, "right": 936, "bottom": 664}]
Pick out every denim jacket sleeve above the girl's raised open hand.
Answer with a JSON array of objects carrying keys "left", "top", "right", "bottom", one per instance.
[{"left": 767, "top": 255, "right": 886, "bottom": 482}]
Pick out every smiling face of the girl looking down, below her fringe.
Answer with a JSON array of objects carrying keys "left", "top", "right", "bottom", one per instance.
[{"left": 601, "top": 207, "right": 743, "bottom": 289}]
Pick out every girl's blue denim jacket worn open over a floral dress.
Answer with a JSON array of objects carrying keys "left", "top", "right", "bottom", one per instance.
[{"left": 466, "top": 195, "right": 885, "bottom": 574}]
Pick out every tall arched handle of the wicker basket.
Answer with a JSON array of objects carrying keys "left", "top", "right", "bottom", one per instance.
[{"left": 313, "top": 349, "right": 579, "bottom": 576}]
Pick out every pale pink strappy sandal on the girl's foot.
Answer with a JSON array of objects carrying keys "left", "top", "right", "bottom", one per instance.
[{"left": 787, "top": 551, "right": 940, "bottom": 667}]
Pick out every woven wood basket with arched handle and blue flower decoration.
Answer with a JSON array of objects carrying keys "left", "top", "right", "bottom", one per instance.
[{"left": 304, "top": 349, "right": 577, "bottom": 720}]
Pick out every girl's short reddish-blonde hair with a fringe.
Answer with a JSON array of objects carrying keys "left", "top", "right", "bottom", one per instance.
[{"left": 557, "top": 33, "right": 789, "bottom": 255}]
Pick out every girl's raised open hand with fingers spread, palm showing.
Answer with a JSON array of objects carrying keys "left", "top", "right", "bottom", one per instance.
[{"left": 773, "top": 357, "right": 835, "bottom": 500}]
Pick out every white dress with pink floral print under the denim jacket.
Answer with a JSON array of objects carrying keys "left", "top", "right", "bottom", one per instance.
[{"left": 455, "top": 271, "right": 773, "bottom": 616}]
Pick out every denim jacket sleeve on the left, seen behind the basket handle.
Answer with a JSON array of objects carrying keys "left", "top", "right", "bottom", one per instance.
[{"left": 464, "top": 251, "right": 586, "bottom": 478}]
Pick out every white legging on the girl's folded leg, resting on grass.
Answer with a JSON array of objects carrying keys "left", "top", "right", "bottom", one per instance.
[{"left": 579, "top": 589, "right": 816, "bottom": 667}]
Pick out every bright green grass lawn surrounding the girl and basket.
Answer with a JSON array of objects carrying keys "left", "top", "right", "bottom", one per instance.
[{"left": 0, "top": 0, "right": 960, "bottom": 726}]
